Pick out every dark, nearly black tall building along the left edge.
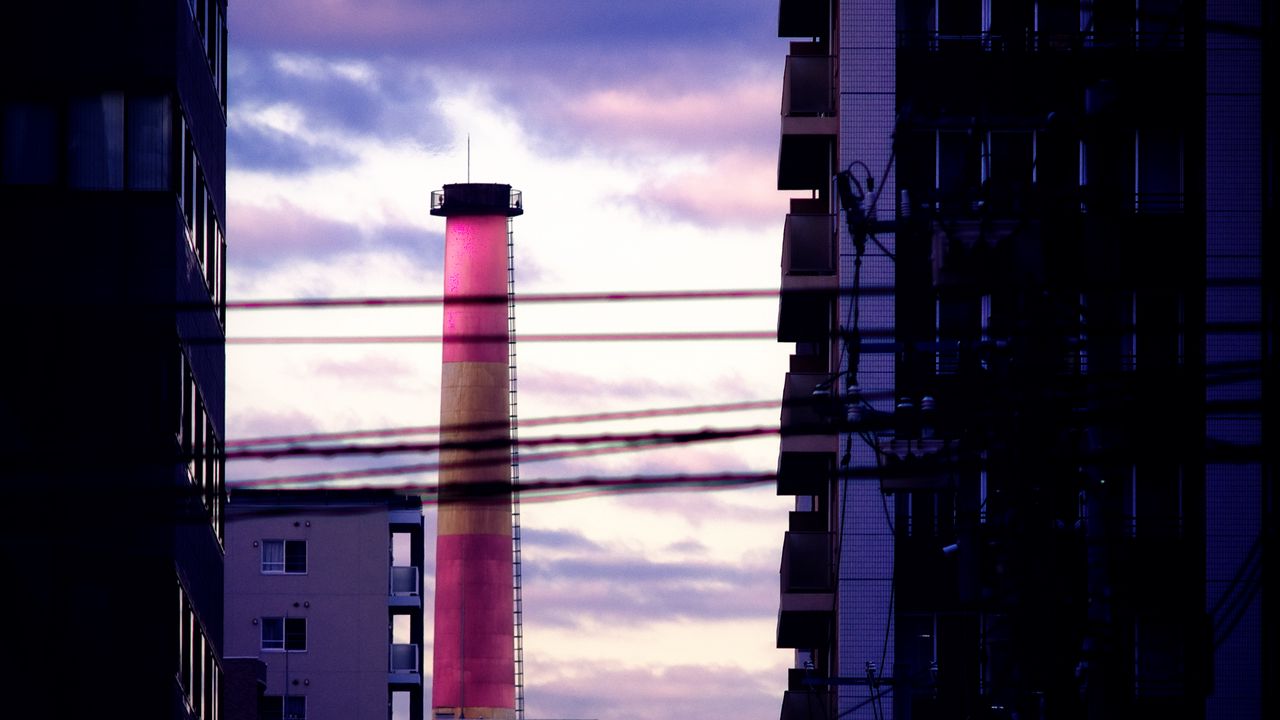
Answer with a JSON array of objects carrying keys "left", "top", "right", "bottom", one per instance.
[{"left": 0, "top": 0, "right": 227, "bottom": 720}]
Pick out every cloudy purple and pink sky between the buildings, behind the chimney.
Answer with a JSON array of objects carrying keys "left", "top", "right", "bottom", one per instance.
[{"left": 227, "top": 0, "right": 790, "bottom": 720}]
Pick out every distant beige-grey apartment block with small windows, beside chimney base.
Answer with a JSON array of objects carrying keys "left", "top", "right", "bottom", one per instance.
[{"left": 227, "top": 489, "right": 425, "bottom": 720}]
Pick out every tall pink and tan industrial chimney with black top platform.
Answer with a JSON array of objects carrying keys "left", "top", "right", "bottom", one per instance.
[{"left": 431, "top": 183, "right": 524, "bottom": 720}]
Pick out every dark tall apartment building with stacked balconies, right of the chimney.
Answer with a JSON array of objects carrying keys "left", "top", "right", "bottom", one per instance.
[{"left": 777, "top": 0, "right": 1277, "bottom": 720}]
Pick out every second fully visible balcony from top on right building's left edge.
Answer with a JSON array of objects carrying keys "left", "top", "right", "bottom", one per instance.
[{"left": 778, "top": 213, "right": 840, "bottom": 342}]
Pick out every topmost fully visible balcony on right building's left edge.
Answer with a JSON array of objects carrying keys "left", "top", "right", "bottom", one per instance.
[{"left": 778, "top": 42, "right": 840, "bottom": 190}]
